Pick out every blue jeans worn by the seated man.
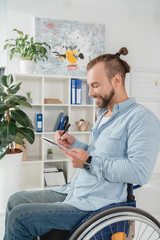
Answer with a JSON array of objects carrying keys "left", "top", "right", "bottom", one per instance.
[{"left": 4, "top": 190, "right": 90, "bottom": 240}]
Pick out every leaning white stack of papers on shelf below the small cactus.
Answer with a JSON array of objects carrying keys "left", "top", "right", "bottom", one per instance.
[{"left": 44, "top": 167, "right": 66, "bottom": 187}]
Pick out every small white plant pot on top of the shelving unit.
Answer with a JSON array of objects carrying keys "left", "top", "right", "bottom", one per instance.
[{"left": 19, "top": 60, "right": 35, "bottom": 73}]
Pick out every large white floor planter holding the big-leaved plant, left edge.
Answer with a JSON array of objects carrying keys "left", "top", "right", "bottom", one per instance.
[{"left": 0, "top": 149, "right": 23, "bottom": 212}]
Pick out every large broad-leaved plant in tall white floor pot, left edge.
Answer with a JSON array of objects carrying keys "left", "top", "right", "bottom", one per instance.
[{"left": 0, "top": 74, "right": 35, "bottom": 211}]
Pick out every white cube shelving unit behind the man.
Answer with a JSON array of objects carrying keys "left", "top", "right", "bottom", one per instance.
[{"left": 14, "top": 74, "right": 96, "bottom": 189}]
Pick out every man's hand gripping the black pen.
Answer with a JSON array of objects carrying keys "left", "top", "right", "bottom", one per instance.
[{"left": 55, "top": 130, "right": 75, "bottom": 148}]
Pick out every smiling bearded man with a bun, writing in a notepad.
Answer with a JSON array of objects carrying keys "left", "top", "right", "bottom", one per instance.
[{"left": 4, "top": 48, "right": 160, "bottom": 240}]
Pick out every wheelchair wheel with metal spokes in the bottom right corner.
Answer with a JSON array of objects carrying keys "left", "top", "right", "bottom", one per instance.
[{"left": 68, "top": 207, "right": 160, "bottom": 240}]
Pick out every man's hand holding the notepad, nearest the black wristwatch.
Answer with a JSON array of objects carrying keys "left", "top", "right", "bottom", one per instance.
[{"left": 59, "top": 148, "right": 89, "bottom": 168}]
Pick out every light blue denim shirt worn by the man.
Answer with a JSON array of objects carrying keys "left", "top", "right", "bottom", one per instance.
[{"left": 56, "top": 98, "right": 160, "bottom": 211}]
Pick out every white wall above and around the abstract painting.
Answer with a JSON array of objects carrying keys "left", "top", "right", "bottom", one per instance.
[{"left": 7, "top": 0, "right": 160, "bottom": 72}]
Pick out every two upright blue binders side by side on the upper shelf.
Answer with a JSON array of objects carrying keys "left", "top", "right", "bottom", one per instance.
[{"left": 71, "top": 78, "right": 82, "bottom": 104}]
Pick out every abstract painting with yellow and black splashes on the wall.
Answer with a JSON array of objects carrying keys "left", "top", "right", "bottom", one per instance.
[{"left": 35, "top": 17, "right": 105, "bottom": 76}]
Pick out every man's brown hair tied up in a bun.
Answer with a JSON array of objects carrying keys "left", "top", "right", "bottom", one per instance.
[{"left": 87, "top": 47, "right": 130, "bottom": 83}]
